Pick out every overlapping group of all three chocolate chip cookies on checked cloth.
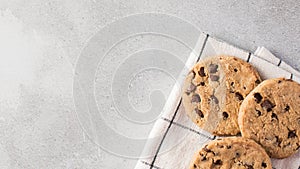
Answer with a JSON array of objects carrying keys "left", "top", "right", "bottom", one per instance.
[{"left": 182, "top": 56, "right": 300, "bottom": 169}]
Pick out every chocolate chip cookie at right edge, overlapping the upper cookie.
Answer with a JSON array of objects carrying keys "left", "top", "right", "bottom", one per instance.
[{"left": 238, "top": 78, "right": 300, "bottom": 158}]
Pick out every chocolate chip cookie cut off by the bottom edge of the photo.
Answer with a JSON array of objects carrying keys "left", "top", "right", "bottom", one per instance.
[{"left": 190, "top": 137, "right": 272, "bottom": 169}]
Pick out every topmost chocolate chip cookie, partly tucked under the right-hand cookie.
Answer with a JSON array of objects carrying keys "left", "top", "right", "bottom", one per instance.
[{"left": 182, "top": 56, "right": 261, "bottom": 135}]
